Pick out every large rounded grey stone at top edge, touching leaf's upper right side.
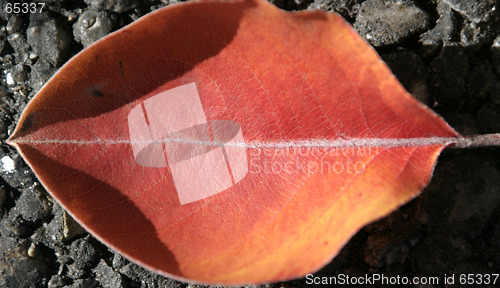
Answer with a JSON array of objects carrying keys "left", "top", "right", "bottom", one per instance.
[{"left": 354, "top": 0, "right": 429, "bottom": 46}]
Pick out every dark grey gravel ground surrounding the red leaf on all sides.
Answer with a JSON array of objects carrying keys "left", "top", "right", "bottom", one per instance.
[{"left": 0, "top": 0, "right": 500, "bottom": 288}]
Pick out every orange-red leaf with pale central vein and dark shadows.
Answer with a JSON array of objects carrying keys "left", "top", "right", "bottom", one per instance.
[{"left": 10, "top": 0, "right": 458, "bottom": 284}]
